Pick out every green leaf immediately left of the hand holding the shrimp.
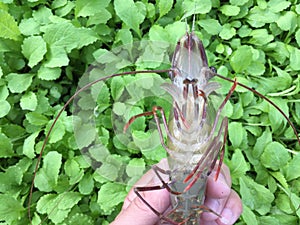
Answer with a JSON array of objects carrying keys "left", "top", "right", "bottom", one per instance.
[{"left": 97, "top": 183, "right": 127, "bottom": 215}]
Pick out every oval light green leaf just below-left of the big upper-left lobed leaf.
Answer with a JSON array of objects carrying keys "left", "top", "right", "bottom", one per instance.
[{"left": 22, "top": 36, "right": 47, "bottom": 68}]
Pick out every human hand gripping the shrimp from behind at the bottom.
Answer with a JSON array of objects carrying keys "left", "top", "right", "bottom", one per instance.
[{"left": 110, "top": 159, "right": 242, "bottom": 225}]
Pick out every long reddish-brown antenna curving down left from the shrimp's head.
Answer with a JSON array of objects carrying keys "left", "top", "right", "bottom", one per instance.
[{"left": 28, "top": 70, "right": 170, "bottom": 224}]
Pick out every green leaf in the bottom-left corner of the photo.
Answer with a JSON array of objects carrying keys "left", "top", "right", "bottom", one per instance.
[{"left": 0, "top": 194, "right": 25, "bottom": 224}]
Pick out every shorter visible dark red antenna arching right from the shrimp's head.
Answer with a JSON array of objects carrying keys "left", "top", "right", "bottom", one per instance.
[{"left": 214, "top": 73, "right": 300, "bottom": 144}]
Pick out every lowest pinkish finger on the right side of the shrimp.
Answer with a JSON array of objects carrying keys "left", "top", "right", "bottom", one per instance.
[{"left": 217, "top": 190, "right": 243, "bottom": 225}]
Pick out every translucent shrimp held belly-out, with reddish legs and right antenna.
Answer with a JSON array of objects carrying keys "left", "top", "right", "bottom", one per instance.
[{"left": 124, "top": 32, "right": 299, "bottom": 225}]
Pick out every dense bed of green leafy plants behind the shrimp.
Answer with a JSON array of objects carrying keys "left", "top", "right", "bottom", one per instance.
[{"left": 0, "top": 0, "right": 300, "bottom": 225}]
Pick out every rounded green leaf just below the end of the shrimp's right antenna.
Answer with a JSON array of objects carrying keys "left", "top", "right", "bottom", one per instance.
[{"left": 260, "top": 142, "right": 290, "bottom": 170}]
